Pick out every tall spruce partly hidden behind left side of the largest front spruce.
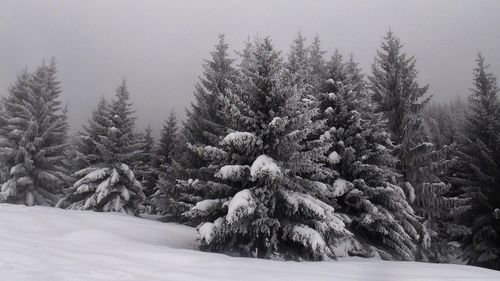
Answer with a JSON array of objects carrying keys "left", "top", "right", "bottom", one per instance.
[{"left": 155, "top": 35, "right": 237, "bottom": 220}]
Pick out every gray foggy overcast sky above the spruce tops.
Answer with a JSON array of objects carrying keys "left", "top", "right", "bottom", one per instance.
[{"left": 0, "top": 0, "right": 500, "bottom": 131}]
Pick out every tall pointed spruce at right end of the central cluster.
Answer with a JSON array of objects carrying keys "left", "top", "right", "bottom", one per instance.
[{"left": 369, "top": 31, "right": 458, "bottom": 261}]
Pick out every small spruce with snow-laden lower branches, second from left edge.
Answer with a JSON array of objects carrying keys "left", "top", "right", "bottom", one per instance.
[{"left": 58, "top": 81, "right": 145, "bottom": 215}]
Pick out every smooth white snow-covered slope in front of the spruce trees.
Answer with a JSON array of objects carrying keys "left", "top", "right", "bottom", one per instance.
[{"left": 0, "top": 204, "right": 500, "bottom": 281}]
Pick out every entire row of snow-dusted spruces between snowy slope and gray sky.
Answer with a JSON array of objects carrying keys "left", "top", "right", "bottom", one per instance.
[{"left": 0, "top": 32, "right": 500, "bottom": 269}]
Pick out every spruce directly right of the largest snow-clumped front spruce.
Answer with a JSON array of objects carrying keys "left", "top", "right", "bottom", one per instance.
[{"left": 318, "top": 55, "right": 422, "bottom": 260}]
